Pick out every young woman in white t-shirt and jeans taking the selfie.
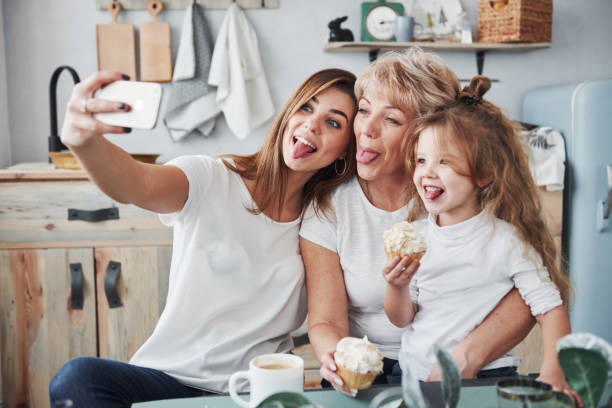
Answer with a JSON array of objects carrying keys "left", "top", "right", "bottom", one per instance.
[{"left": 49, "top": 69, "right": 356, "bottom": 407}]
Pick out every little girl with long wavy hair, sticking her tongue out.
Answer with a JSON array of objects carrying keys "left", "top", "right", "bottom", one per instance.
[{"left": 383, "top": 76, "right": 577, "bottom": 399}]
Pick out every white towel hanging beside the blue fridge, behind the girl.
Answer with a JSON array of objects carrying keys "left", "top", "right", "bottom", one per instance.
[{"left": 522, "top": 127, "right": 565, "bottom": 191}]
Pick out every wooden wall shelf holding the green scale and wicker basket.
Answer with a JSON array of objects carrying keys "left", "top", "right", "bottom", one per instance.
[{"left": 324, "top": 41, "right": 550, "bottom": 74}]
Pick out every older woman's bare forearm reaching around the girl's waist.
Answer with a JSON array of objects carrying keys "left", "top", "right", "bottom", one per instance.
[{"left": 427, "top": 289, "right": 535, "bottom": 381}]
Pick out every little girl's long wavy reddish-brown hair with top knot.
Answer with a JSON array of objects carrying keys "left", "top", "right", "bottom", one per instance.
[{"left": 407, "top": 76, "right": 571, "bottom": 304}]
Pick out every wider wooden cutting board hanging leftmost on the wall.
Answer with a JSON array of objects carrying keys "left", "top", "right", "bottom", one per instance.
[{"left": 96, "top": 1, "right": 137, "bottom": 80}]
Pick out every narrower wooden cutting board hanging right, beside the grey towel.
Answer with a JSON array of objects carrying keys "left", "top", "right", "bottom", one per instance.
[{"left": 140, "top": 0, "right": 172, "bottom": 82}]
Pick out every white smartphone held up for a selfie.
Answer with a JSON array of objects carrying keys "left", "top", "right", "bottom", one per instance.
[{"left": 94, "top": 81, "right": 162, "bottom": 129}]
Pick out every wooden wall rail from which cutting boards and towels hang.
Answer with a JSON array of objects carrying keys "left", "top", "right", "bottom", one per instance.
[{"left": 96, "top": 0, "right": 279, "bottom": 10}]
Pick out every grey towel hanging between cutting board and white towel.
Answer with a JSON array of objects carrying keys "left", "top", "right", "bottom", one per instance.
[{"left": 164, "top": 3, "right": 220, "bottom": 142}]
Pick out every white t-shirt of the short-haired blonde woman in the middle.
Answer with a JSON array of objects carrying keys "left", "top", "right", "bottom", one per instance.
[{"left": 300, "top": 177, "right": 410, "bottom": 359}]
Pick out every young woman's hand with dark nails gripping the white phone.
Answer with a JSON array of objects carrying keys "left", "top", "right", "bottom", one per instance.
[{"left": 61, "top": 71, "right": 131, "bottom": 147}]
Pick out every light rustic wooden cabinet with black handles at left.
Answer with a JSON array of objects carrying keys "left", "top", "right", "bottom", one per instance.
[{"left": 0, "top": 166, "right": 172, "bottom": 407}]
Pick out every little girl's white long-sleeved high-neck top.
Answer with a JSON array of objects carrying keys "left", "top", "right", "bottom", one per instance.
[{"left": 401, "top": 211, "right": 562, "bottom": 380}]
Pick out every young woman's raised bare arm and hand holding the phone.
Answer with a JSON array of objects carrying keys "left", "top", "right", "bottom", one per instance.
[{"left": 61, "top": 71, "right": 189, "bottom": 213}]
